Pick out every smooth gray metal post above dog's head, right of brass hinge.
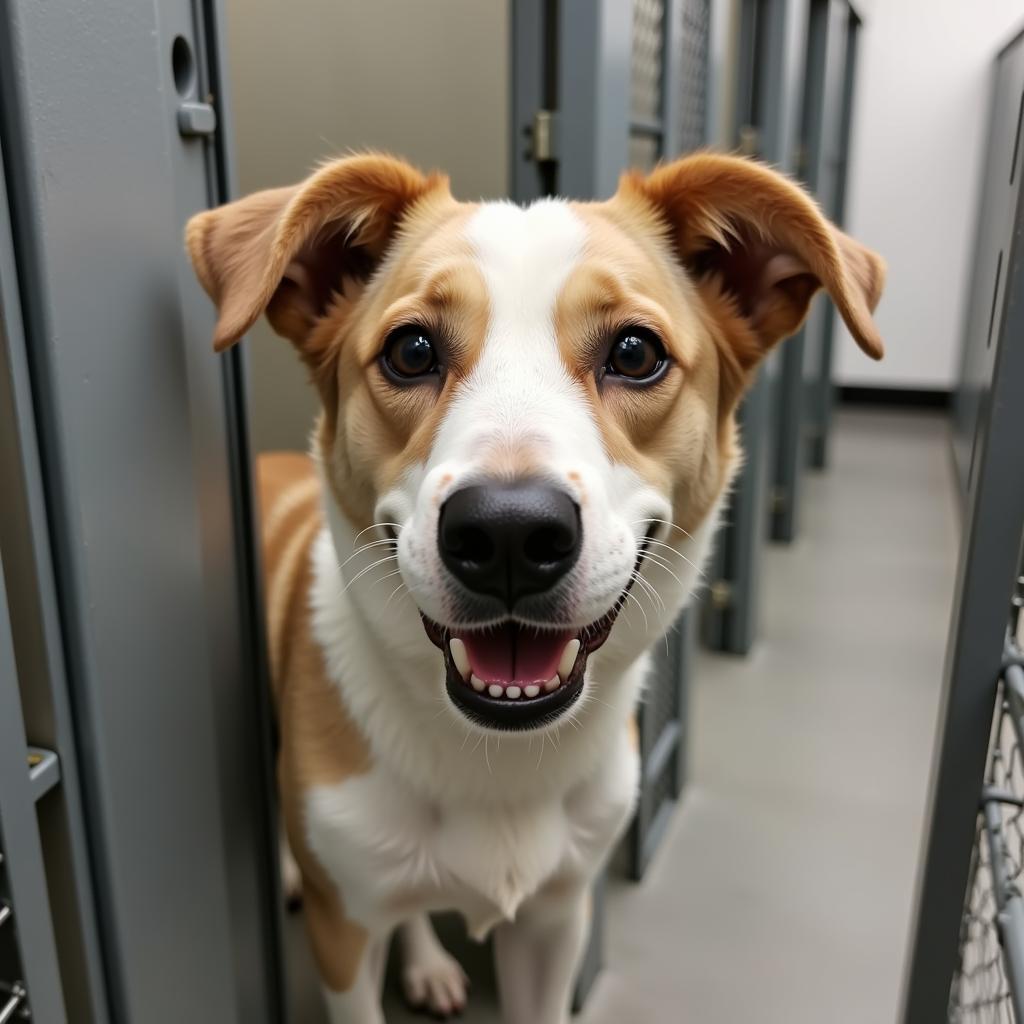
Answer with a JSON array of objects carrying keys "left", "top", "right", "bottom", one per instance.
[{"left": 558, "top": 0, "right": 632, "bottom": 199}]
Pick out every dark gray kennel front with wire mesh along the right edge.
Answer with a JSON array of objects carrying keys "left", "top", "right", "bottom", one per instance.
[{"left": 900, "top": 18, "right": 1024, "bottom": 1024}]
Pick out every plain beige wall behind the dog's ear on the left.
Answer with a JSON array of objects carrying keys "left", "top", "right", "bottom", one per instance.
[{"left": 227, "top": 0, "right": 510, "bottom": 451}]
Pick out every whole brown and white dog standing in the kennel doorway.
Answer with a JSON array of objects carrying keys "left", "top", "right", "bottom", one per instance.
[{"left": 187, "top": 154, "right": 884, "bottom": 1024}]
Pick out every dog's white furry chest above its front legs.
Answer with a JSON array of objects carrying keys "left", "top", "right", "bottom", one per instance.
[{"left": 306, "top": 754, "right": 636, "bottom": 937}]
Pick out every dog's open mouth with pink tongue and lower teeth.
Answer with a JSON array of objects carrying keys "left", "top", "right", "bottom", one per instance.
[{"left": 423, "top": 596, "right": 625, "bottom": 729}]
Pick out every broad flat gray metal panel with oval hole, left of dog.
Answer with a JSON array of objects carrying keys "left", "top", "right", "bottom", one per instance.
[{"left": 4, "top": 0, "right": 274, "bottom": 1024}]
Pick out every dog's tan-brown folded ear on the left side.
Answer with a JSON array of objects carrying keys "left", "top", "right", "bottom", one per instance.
[{"left": 185, "top": 154, "right": 447, "bottom": 357}]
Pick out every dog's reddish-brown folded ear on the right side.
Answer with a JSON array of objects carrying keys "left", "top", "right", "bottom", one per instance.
[{"left": 620, "top": 153, "right": 885, "bottom": 371}]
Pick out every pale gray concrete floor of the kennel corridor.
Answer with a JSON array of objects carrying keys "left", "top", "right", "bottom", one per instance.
[{"left": 282, "top": 410, "right": 958, "bottom": 1024}]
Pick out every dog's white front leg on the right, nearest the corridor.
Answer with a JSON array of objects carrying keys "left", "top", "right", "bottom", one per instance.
[{"left": 495, "top": 884, "right": 590, "bottom": 1024}]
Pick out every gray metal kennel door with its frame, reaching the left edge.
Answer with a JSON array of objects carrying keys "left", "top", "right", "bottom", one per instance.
[{"left": 0, "top": 0, "right": 282, "bottom": 1024}]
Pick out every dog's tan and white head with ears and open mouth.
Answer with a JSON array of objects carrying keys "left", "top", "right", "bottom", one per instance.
[{"left": 187, "top": 154, "right": 884, "bottom": 728}]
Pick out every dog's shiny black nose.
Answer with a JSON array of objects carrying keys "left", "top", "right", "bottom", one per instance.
[{"left": 437, "top": 479, "right": 582, "bottom": 608}]
